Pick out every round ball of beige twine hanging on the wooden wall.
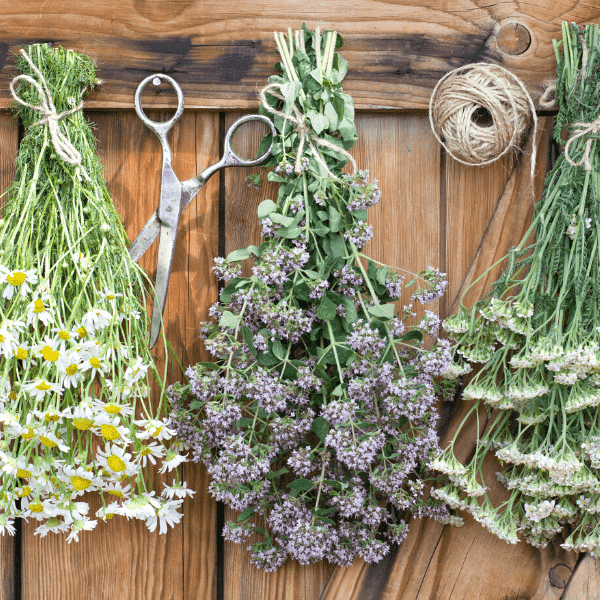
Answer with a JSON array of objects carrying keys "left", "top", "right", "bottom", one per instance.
[{"left": 429, "top": 63, "right": 537, "bottom": 169}]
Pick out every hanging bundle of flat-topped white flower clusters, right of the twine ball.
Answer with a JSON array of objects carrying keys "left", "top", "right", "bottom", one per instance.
[{"left": 433, "top": 24, "right": 600, "bottom": 555}]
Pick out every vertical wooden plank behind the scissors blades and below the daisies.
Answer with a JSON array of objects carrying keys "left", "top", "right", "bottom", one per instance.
[{"left": 22, "top": 111, "right": 218, "bottom": 600}]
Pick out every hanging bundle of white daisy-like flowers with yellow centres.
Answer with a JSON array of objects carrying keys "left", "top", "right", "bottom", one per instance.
[{"left": 0, "top": 45, "right": 189, "bottom": 542}]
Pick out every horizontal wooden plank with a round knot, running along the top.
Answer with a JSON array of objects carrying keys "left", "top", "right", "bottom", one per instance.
[{"left": 0, "top": 0, "right": 600, "bottom": 110}]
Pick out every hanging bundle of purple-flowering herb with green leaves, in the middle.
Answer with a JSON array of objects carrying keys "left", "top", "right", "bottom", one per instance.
[{"left": 166, "top": 29, "right": 450, "bottom": 571}]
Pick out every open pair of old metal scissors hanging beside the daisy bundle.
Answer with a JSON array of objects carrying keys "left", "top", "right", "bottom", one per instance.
[{"left": 129, "top": 73, "right": 276, "bottom": 348}]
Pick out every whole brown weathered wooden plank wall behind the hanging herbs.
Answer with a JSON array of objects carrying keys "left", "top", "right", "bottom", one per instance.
[{"left": 0, "top": 0, "right": 600, "bottom": 600}]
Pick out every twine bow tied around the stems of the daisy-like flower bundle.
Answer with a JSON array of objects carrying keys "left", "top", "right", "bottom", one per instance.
[{"left": 10, "top": 49, "right": 91, "bottom": 181}]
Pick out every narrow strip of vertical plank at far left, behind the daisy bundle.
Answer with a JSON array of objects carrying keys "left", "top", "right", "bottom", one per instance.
[{"left": 0, "top": 113, "right": 20, "bottom": 600}]
